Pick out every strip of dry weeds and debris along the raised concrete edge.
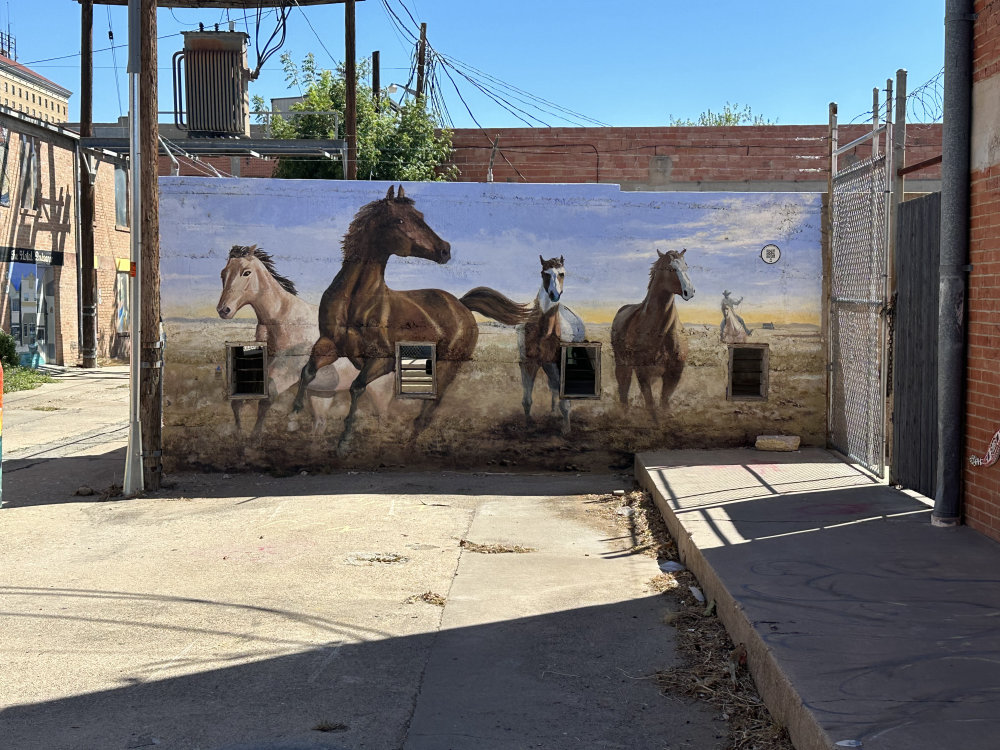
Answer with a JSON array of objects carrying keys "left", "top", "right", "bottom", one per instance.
[{"left": 590, "top": 490, "right": 794, "bottom": 750}]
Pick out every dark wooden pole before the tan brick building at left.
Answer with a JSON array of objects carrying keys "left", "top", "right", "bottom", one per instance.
[{"left": 79, "top": 0, "right": 97, "bottom": 367}]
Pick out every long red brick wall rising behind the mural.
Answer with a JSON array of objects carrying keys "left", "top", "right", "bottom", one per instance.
[{"left": 442, "top": 124, "right": 941, "bottom": 190}]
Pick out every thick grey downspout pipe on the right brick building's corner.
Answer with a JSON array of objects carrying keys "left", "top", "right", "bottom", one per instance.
[{"left": 931, "top": 0, "right": 975, "bottom": 526}]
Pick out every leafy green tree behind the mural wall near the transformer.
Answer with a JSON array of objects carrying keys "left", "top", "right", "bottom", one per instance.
[{"left": 254, "top": 53, "right": 458, "bottom": 181}]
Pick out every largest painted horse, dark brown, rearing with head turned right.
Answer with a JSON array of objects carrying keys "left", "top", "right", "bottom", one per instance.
[{"left": 293, "top": 185, "right": 528, "bottom": 456}]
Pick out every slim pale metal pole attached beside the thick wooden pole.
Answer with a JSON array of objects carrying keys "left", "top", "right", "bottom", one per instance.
[{"left": 122, "top": 0, "right": 143, "bottom": 497}]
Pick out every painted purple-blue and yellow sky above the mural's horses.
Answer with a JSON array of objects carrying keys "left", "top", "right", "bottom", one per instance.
[{"left": 160, "top": 177, "right": 821, "bottom": 324}]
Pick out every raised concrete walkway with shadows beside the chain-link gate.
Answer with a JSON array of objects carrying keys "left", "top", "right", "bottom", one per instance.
[{"left": 636, "top": 449, "right": 1000, "bottom": 750}]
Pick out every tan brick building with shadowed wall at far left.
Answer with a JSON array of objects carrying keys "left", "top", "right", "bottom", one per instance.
[{"left": 0, "top": 109, "right": 130, "bottom": 365}]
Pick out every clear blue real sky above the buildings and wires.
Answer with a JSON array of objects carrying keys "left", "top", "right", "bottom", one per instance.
[{"left": 15, "top": 0, "right": 944, "bottom": 127}]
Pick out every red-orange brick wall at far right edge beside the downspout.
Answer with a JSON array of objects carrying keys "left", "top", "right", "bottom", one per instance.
[{"left": 964, "top": 0, "right": 1000, "bottom": 539}]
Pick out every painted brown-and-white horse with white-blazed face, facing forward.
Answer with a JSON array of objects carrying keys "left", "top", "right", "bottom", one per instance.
[{"left": 517, "top": 255, "right": 587, "bottom": 433}]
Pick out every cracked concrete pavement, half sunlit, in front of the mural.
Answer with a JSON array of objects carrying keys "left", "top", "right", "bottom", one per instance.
[{"left": 0, "top": 370, "right": 726, "bottom": 750}]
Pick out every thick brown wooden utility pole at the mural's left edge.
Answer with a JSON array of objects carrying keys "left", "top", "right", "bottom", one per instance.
[{"left": 140, "top": 0, "right": 163, "bottom": 490}]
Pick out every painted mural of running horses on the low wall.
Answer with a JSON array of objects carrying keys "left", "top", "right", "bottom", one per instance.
[{"left": 160, "top": 177, "right": 825, "bottom": 470}]
